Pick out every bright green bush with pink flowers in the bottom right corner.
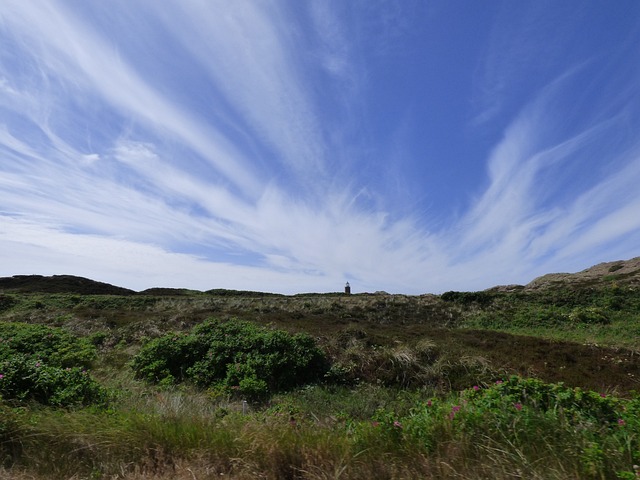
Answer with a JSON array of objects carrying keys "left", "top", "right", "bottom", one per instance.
[{"left": 368, "top": 376, "right": 640, "bottom": 479}]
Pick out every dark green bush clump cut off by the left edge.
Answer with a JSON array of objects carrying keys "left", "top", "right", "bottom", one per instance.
[{"left": 0, "top": 323, "right": 106, "bottom": 406}]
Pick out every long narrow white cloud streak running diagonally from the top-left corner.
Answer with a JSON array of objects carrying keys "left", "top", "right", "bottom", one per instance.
[{"left": 1, "top": 0, "right": 259, "bottom": 196}]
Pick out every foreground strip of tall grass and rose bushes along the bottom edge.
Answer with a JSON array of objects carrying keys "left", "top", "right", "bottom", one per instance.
[{"left": 2, "top": 378, "right": 640, "bottom": 480}]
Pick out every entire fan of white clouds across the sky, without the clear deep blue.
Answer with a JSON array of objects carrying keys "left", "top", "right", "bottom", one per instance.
[{"left": 0, "top": 0, "right": 640, "bottom": 293}]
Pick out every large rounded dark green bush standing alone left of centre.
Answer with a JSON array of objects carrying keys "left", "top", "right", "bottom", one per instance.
[{"left": 132, "top": 320, "right": 327, "bottom": 398}]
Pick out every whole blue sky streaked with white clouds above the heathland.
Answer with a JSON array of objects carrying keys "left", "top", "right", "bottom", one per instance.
[{"left": 0, "top": 0, "right": 640, "bottom": 294}]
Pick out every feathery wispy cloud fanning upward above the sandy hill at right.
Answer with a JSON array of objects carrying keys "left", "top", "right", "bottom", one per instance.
[{"left": 454, "top": 71, "right": 640, "bottom": 284}]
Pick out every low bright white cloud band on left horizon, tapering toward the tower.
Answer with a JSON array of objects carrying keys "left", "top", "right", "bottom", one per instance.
[{"left": 0, "top": 215, "right": 340, "bottom": 293}]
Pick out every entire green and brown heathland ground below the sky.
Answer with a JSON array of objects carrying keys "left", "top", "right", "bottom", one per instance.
[{"left": 0, "top": 265, "right": 640, "bottom": 480}]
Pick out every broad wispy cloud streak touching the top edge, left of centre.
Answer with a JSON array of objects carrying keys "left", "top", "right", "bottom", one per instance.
[{"left": 154, "top": 1, "right": 325, "bottom": 177}]
